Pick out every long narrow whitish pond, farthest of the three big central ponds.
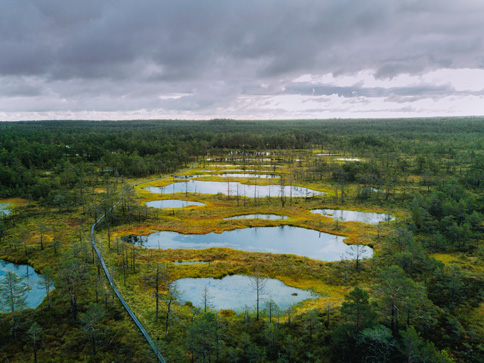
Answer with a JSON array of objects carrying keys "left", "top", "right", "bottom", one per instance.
[{"left": 146, "top": 180, "right": 324, "bottom": 197}]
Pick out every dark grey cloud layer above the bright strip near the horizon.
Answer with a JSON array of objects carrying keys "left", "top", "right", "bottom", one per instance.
[{"left": 0, "top": 0, "right": 484, "bottom": 118}]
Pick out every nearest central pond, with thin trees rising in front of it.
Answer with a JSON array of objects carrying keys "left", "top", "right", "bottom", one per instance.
[{"left": 176, "top": 275, "right": 317, "bottom": 311}]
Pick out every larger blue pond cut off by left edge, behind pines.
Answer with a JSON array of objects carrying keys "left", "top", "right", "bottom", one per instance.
[{"left": 0, "top": 260, "right": 53, "bottom": 312}]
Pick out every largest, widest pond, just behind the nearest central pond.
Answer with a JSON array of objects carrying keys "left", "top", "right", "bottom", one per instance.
[{"left": 123, "top": 226, "right": 373, "bottom": 261}]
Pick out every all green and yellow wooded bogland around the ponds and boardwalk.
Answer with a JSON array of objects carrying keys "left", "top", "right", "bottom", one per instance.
[{"left": 0, "top": 118, "right": 484, "bottom": 362}]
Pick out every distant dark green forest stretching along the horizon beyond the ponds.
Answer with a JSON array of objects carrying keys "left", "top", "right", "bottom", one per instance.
[{"left": 0, "top": 118, "right": 484, "bottom": 199}]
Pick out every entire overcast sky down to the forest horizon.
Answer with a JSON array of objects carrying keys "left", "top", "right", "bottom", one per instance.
[{"left": 0, "top": 0, "right": 484, "bottom": 120}]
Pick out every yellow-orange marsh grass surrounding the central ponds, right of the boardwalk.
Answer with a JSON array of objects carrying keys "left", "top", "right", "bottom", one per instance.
[{"left": 98, "top": 153, "right": 404, "bottom": 334}]
